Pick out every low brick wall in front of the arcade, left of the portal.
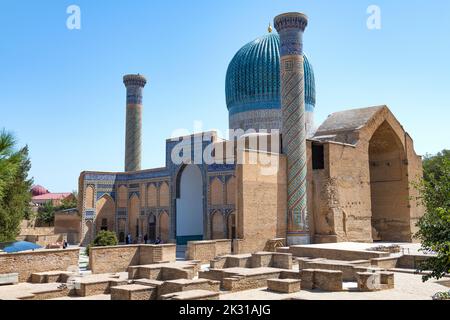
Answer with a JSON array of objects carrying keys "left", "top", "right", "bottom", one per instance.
[{"left": 89, "top": 244, "right": 176, "bottom": 273}]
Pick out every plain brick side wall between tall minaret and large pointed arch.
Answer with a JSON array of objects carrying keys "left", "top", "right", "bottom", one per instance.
[{"left": 308, "top": 143, "right": 372, "bottom": 243}]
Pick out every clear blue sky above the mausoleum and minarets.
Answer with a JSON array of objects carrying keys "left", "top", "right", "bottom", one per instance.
[{"left": 0, "top": 0, "right": 450, "bottom": 192}]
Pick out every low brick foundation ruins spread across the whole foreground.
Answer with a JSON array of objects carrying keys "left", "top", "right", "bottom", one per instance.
[{"left": 0, "top": 241, "right": 442, "bottom": 300}]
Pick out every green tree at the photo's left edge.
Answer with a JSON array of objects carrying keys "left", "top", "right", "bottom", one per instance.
[{"left": 0, "top": 130, "right": 33, "bottom": 242}]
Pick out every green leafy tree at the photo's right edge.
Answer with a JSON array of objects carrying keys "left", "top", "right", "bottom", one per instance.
[{"left": 416, "top": 150, "right": 450, "bottom": 281}]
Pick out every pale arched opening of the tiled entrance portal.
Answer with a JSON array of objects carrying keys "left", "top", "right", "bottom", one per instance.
[{"left": 176, "top": 164, "right": 203, "bottom": 245}]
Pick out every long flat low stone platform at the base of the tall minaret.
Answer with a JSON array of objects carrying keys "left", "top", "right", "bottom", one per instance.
[{"left": 289, "top": 245, "right": 389, "bottom": 261}]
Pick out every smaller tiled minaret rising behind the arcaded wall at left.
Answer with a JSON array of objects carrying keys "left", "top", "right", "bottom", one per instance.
[{"left": 123, "top": 74, "right": 147, "bottom": 172}]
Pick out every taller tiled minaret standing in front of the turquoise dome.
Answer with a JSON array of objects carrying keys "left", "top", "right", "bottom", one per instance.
[{"left": 274, "top": 12, "right": 310, "bottom": 245}]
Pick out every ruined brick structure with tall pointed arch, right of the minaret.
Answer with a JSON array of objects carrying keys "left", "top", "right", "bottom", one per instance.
[{"left": 308, "top": 107, "right": 423, "bottom": 242}]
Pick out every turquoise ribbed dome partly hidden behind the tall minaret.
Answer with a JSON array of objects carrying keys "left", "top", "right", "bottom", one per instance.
[{"left": 225, "top": 33, "right": 316, "bottom": 115}]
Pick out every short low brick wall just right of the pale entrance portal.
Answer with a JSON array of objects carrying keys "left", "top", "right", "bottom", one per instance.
[{"left": 186, "top": 240, "right": 231, "bottom": 262}]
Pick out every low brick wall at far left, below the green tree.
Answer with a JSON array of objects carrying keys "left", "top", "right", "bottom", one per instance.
[{"left": 0, "top": 248, "right": 80, "bottom": 282}]
